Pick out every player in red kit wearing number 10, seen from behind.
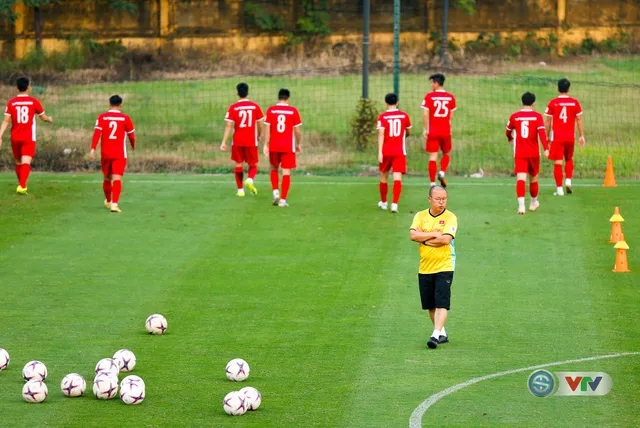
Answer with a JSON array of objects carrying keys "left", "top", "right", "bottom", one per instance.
[{"left": 378, "top": 94, "right": 411, "bottom": 213}]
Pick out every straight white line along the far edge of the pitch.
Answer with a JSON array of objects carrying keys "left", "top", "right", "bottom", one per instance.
[{"left": 0, "top": 180, "right": 640, "bottom": 188}]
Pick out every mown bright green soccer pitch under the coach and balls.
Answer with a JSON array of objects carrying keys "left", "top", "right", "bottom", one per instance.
[{"left": 0, "top": 174, "right": 640, "bottom": 427}]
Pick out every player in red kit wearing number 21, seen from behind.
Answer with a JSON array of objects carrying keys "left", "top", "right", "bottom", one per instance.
[{"left": 220, "top": 83, "right": 264, "bottom": 196}]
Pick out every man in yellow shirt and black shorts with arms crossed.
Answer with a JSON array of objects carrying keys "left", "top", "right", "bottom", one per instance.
[{"left": 410, "top": 186, "right": 458, "bottom": 349}]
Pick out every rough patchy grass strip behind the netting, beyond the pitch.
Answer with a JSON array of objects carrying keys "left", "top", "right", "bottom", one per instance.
[{"left": 0, "top": 57, "right": 640, "bottom": 178}]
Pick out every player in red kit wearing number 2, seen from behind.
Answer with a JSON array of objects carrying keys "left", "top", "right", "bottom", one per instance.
[{"left": 89, "top": 95, "right": 136, "bottom": 213}]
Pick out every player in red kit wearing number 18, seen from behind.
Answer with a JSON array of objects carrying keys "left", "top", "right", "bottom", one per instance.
[{"left": 0, "top": 77, "right": 53, "bottom": 195}]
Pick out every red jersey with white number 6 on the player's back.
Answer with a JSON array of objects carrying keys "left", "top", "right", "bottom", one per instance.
[{"left": 506, "top": 109, "right": 548, "bottom": 158}]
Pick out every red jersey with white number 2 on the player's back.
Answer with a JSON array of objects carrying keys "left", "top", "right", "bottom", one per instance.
[{"left": 91, "top": 110, "right": 136, "bottom": 159}]
